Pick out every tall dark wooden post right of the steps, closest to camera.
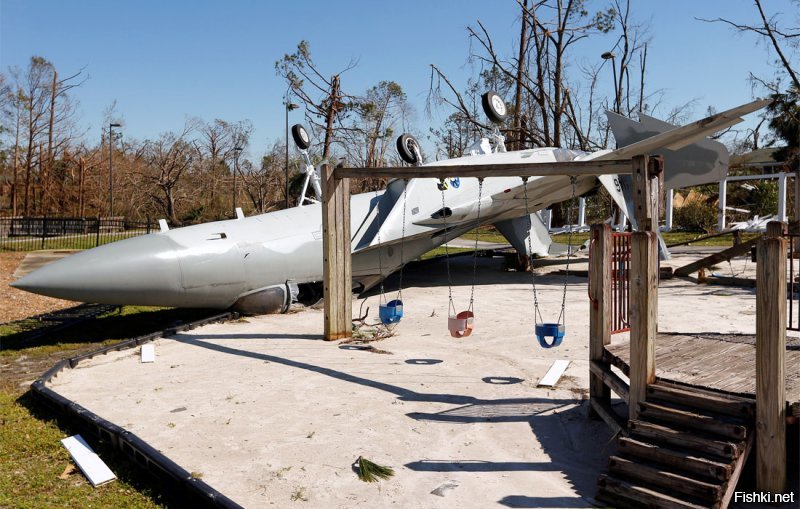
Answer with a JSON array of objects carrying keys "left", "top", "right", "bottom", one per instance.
[{"left": 756, "top": 235, "right": 786, "bottom": 493}]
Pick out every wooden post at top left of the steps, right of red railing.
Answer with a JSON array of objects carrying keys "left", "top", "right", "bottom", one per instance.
[{"left": 628, "top": 232, "right": 658, "bottom": 420}]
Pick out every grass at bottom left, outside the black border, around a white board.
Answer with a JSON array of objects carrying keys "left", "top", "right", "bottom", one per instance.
[{"left": 0, "top": 306, "right": 222, "bottom": 509}]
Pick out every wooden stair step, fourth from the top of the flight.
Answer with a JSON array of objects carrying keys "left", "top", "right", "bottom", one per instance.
[{"left": 618, "top": 438, "right": 733, "bottom": 481}]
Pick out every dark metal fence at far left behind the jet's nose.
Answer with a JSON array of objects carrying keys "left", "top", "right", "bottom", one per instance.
[{"left": 0, "top": 217, "right": 158, "bottom": 251}]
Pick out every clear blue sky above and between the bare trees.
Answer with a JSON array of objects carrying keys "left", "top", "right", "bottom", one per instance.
[{"left": 0, "top": 0, "right": 797, "bottom": 157}]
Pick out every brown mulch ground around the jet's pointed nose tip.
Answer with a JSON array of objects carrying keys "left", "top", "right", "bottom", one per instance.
[{"left": 0, "top": 253, "right": 78, "bottom": 324}]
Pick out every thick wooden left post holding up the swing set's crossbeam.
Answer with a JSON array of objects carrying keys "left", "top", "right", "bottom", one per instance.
[{"left": 322, "top": 164, "right": 353, "bottom": 341}]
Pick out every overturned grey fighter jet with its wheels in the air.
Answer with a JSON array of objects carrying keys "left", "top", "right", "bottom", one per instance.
[{"left": 12, "top": 92, "right": 768, "bottom": 314}]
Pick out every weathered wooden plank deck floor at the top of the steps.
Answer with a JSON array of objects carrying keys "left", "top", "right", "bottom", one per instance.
[{"left": 605, "top": 333, "right": 800, "bottom": 408}]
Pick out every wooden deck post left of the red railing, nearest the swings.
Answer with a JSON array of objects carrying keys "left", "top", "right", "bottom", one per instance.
[{"left": 589, "top": 224, "right": 612, "bottom": 416}]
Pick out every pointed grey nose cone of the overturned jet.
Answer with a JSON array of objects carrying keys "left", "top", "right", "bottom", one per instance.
[{"left": 11, "top": 234, "right": 181, "bottom": 305}]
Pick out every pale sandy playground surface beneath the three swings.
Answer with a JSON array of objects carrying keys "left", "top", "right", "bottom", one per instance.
[{"left": 43, "top": 258, "right": 768, "bottom": 508}]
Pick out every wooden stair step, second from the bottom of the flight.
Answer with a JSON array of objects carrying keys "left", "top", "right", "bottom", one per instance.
[{"left": 608, "top": 456, "right": 722, "bottom": 502}]
